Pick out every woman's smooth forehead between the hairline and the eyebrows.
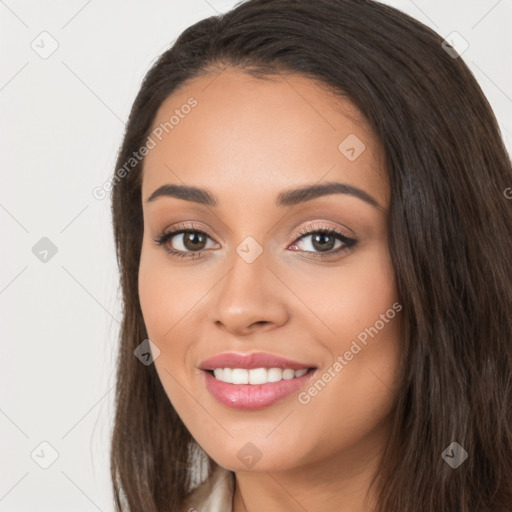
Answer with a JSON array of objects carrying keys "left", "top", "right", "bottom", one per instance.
[{"left": 142, "top": 69, "right": 388, "bottom": 209}]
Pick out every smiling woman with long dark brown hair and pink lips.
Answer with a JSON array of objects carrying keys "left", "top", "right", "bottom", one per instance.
[{"left": 111, "top": 0, "right": 512, "bottom": 512}]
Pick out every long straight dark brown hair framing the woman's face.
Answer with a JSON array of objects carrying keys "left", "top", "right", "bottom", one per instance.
[{"left": 111, "top": 0, "right": 512, "bottom": 512}]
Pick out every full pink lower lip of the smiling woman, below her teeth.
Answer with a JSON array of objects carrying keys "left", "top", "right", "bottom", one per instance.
[{"left": 203, "top": 369, "right": 316, "bottom": 410}]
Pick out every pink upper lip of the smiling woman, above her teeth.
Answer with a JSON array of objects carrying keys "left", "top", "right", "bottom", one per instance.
[{"left": 199, "top": 352, "right": 315, "bottom": 370}]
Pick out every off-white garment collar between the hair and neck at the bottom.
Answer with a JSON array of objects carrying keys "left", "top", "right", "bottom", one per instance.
[{"left": 181, "top": 466, "right": 235, "bottom": 512}]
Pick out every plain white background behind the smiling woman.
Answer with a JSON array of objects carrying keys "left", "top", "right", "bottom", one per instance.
[{"left": 0, "top": 0, "right": 512, "bottom": 512}]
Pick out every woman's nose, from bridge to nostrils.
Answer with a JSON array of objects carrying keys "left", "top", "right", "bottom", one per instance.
[{"left": 213, "top": 248, "right": 291, "bottom": 336}]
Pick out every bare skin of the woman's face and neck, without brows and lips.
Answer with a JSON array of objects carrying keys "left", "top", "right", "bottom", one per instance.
[{"left": 139, "top": 68, "right": 401, "bottom": 512}]
